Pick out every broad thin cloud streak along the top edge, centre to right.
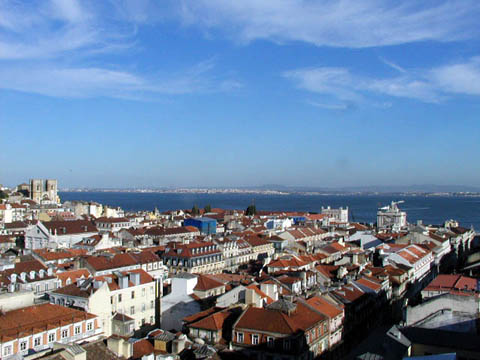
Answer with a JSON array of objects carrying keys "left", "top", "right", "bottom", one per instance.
[{"left": 179, "top": 0, "right": 480, "bottom": 48}]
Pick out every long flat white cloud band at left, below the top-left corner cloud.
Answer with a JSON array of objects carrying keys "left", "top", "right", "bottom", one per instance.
[{"left": 0, "top": 64, "right": 241, "bottom": 100}]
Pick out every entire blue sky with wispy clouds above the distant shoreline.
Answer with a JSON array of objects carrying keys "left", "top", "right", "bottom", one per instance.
[{"left": 0, "top": 0, "right": 480, "bottom": 188}]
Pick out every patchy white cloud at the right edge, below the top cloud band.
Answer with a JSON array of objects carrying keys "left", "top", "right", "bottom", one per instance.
[{"left": 283, "top": 57, "right": 480, "bottom": 105}]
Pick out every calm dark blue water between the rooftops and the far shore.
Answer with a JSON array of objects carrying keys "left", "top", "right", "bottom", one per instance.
[{"left": 60, "top": 192, "right": 480, "bottom": 231}]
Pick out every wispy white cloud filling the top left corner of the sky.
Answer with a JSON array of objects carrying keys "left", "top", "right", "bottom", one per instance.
[{"left": 0, "top": 0, "right": 126, "bottom": 60}]
